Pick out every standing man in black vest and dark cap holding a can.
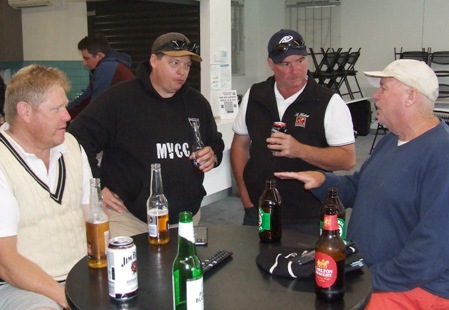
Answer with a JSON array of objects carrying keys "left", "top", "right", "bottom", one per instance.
[{"left": 231, "top": 30, "right": 355, "bottom": 235}]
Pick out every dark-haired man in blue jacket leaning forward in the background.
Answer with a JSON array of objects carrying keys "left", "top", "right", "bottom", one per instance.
[{"left": 68, "top": 34, "right": 134, "bottom": 118}]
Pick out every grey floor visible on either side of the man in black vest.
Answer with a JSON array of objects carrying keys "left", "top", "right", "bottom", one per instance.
[{"left": 200, "top": 127, "right": 376, "bottom": 226}]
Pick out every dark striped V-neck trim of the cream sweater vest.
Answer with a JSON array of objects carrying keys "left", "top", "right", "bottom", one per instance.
[{"left": 0, "top": 133, "right": 67, "bottom": 204}]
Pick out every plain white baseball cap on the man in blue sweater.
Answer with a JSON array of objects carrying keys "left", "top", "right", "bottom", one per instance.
[{"left": 363, "top": 59, "right": 438, "bottom": 102}]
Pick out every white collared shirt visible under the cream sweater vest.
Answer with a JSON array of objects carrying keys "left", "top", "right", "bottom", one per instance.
[{"left": 0, "top": 123, "right": 92, "bottom": 237}]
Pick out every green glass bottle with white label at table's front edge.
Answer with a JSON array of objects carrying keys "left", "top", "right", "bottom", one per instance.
[{"left": 173, "top": 211, "right": 204, "bottom": 310}]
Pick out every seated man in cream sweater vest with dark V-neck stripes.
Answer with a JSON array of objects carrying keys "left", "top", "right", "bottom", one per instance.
[{"left": 0, "top": 65, "right": 92, "bottom": 309}]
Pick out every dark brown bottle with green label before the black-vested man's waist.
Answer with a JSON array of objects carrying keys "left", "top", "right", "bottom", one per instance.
[{"left": 259, "top": 179, "right": 282, "bottom": 243}]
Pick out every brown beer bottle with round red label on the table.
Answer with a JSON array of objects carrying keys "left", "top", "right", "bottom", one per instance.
[{"left": 315, "top": 204, "right": 346, "bottom": 302}]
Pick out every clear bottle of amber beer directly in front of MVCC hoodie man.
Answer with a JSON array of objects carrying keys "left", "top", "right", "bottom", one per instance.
[{"left": 147, "top": 163, "right": 170, "bottom": 245}]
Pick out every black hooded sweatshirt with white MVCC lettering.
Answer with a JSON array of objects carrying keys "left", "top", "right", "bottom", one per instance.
[{"left": 68, "top": 62, "right": 224, "bottom": 224}]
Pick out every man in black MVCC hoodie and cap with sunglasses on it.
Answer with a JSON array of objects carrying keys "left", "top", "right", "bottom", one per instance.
[{"left": 69, "top": 32, "right": 224, "bottom": 235}]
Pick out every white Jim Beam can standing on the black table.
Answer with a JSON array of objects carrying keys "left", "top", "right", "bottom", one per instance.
[{"left": 107, "top": 237, "right": 138, "bottom": 301}]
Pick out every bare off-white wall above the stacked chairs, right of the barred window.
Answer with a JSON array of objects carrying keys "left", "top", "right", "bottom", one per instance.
[{"left": 341, "top": 0, "right": 449, "bottom": 96}]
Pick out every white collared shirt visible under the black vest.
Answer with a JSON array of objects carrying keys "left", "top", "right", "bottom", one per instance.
[{"left": 232, "top": 83, "right": 355, "bottom": 146}]
